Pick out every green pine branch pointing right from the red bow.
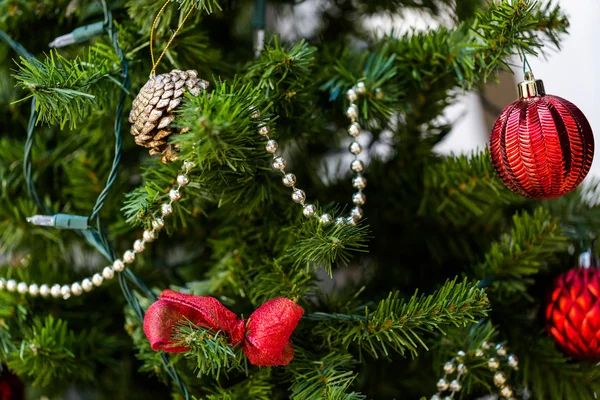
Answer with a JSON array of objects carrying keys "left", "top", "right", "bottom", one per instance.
[{"left": 307, "top": 279, "right": 489, "bottom": 358}]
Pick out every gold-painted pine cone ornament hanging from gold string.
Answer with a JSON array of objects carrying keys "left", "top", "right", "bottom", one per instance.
[{"left": 129, "top": 69, "right": 208, "bottom": 164}]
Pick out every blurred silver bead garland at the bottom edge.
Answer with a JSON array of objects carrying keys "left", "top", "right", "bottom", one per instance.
[{"left": 430, "top": 342, "right": 519, "bottom": 400}]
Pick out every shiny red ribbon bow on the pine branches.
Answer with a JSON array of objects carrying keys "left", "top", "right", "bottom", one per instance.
[{"left": 144, "top": 289, "right": 304, "bottom": 367}]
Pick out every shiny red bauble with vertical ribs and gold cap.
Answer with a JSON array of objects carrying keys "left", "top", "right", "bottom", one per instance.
[{"left": 490, "top": 72, "right": 594, "bottom": 199}]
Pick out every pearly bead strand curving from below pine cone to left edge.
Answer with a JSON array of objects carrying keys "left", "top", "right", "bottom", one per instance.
[{"left": 0, "top": 160, "right": 195, "bottom": 300}]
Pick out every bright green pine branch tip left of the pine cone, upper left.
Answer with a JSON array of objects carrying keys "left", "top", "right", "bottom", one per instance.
[{"left": 15, "top": 45, "right": 120, "bottom": 128}]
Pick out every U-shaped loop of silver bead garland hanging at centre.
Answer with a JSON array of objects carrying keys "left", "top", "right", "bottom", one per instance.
[{"left": 260, "top": 82, "right": 372, "bottom": 225}]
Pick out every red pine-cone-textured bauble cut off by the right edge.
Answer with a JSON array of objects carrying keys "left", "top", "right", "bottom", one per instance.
[{"left": 546, "top": 253, "right": 600, "bottom": 362}]
